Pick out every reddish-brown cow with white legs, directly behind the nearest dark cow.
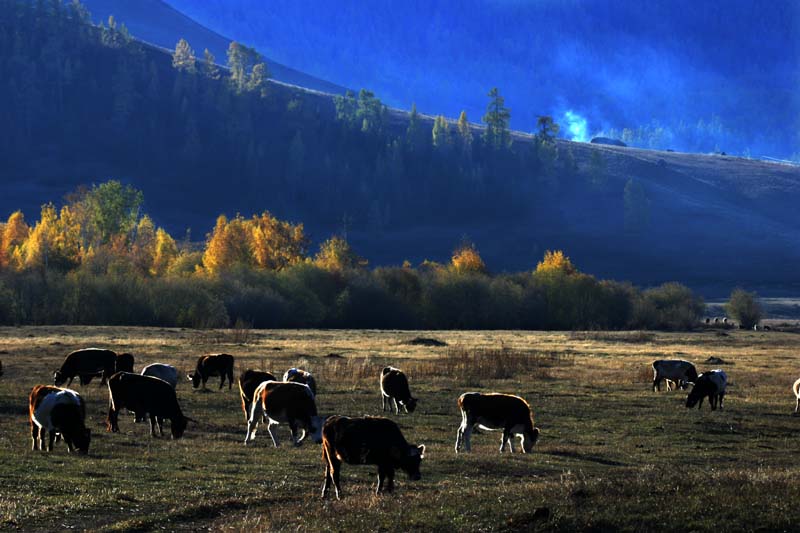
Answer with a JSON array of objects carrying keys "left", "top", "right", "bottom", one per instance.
[{"left": 244, "top": 381, "right": 324, "bottom": 448}]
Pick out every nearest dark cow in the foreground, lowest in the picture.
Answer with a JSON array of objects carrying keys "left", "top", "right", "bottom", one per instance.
[{"left": 322, "top": 416, "right": 425, "bottom": 499}]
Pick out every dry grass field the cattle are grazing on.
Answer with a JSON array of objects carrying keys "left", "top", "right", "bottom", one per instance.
[{"left": 0, "top": 327, "right": 800, "bottom": 531}]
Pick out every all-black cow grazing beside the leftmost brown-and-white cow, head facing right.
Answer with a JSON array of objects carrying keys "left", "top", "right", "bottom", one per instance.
[{"left": 106, "top": 372, "right": 191, "bottom": 439}]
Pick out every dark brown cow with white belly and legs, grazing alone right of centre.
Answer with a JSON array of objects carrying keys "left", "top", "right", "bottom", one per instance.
[{"left": 456, "top": 392, "right": 539, "bottom": 453}]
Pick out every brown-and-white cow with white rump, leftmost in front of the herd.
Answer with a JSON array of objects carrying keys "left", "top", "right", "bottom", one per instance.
[{"left": 28, "top": 385, "right": 92, "bottom": 454}]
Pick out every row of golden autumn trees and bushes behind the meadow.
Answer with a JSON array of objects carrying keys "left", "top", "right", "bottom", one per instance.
[{"left": 0, "top": 180, "right": 705, "bottom": 329}]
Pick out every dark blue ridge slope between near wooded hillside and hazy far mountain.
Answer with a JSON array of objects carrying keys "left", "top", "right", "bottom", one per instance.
[{"left": 77, "top": 0, "right": 345, "bottom": 94}]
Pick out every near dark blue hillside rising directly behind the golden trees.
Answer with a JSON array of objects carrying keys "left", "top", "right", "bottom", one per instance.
[{"left": 0, "top": 0, "right": 800, "bottom": 294}]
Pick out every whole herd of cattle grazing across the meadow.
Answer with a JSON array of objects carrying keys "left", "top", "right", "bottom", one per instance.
[{"left": 10, "top": 348, "right": 776, "bottom": 498}]
